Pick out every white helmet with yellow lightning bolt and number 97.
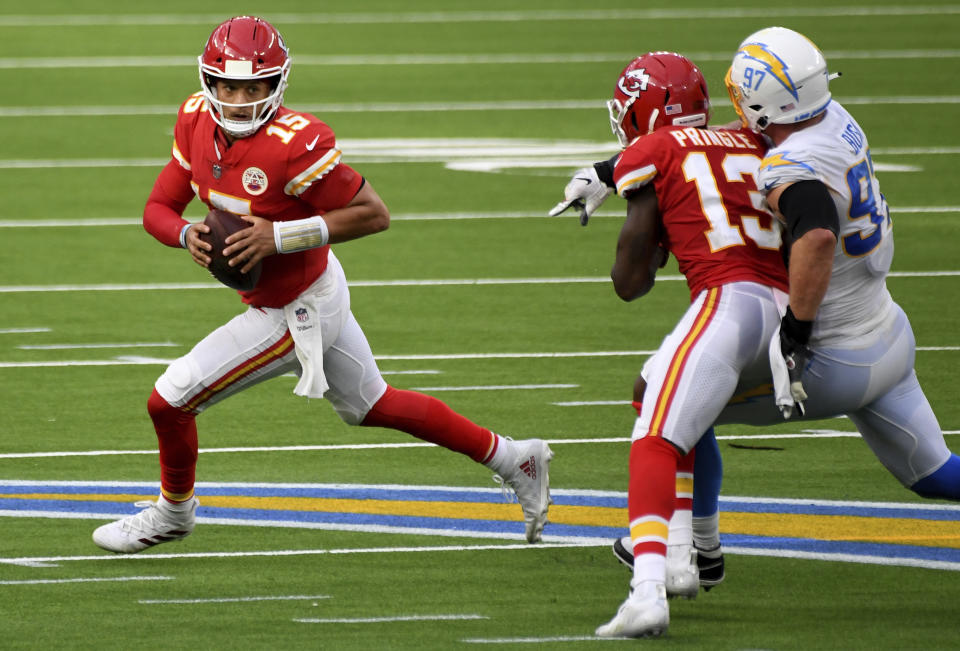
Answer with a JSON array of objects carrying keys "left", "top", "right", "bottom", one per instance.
[{"left": 724, "top": 27, "right": 839, "bottom": 132}]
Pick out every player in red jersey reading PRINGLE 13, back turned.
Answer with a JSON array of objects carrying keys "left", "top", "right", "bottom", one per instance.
[{"left": 552, "top": 52, "right": 787, "bottom": 637}]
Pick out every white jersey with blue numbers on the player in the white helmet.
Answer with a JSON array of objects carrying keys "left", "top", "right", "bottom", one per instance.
[{"left": 757, "top": 101, "right": 893, "bottom": 347}]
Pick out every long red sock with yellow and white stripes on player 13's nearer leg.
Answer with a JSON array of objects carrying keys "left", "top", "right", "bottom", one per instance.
[{"left": 627, "top": 435, "right": 680, "bottom": 557}]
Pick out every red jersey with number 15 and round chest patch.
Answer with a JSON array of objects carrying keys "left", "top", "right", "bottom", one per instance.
[{"left": 144, "top": 93, "right": 363, "bottom": 308}]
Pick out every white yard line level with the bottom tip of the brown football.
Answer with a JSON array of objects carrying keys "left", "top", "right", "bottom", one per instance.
[{"left": 0, "top": 271, "right": 960, "bottom": 294}]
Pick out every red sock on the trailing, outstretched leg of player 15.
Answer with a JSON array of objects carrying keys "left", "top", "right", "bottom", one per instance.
[{"left": 360, "top": 386, "right": 497, "bottom": 463}]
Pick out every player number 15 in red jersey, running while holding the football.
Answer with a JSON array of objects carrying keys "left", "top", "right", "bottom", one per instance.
[{"left": 93, "top": 16, "right": 553, "bottom": 553}]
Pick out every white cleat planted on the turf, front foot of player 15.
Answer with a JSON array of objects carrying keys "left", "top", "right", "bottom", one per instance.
[{"left": 93, "top": 497, "right": 200, "bottom": 554}]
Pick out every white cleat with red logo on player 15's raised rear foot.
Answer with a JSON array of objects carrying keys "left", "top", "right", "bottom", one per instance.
[{"left": 493, "top": 439, "right": 553, "bottom": 543}]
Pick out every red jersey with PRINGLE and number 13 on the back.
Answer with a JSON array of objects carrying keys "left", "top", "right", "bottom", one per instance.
[{"left": 613, "top": 127, "right": 787, "bottom": 297}]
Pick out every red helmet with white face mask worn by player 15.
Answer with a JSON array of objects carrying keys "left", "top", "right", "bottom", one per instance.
[{"left": 197, "top": 16, "right": 290, "bottom": 138}]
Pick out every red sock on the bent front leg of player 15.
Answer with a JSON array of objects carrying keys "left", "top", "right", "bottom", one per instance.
[{"left": 147, "top": 389, "right": 197, "bottom": 502}]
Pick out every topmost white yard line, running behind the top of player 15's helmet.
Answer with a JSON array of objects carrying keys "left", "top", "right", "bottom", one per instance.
[{"left": 7, "top": 5, "right": 960, "bottom": 27}]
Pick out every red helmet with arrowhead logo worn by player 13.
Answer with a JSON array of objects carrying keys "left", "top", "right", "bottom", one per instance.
[{"left": 607, "top": 52, "right": 710, "bottom": 147}]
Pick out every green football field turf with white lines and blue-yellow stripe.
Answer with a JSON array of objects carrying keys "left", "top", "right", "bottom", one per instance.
[{"left": 0, "top": 0, "right": 960, "bottom": 650}]
